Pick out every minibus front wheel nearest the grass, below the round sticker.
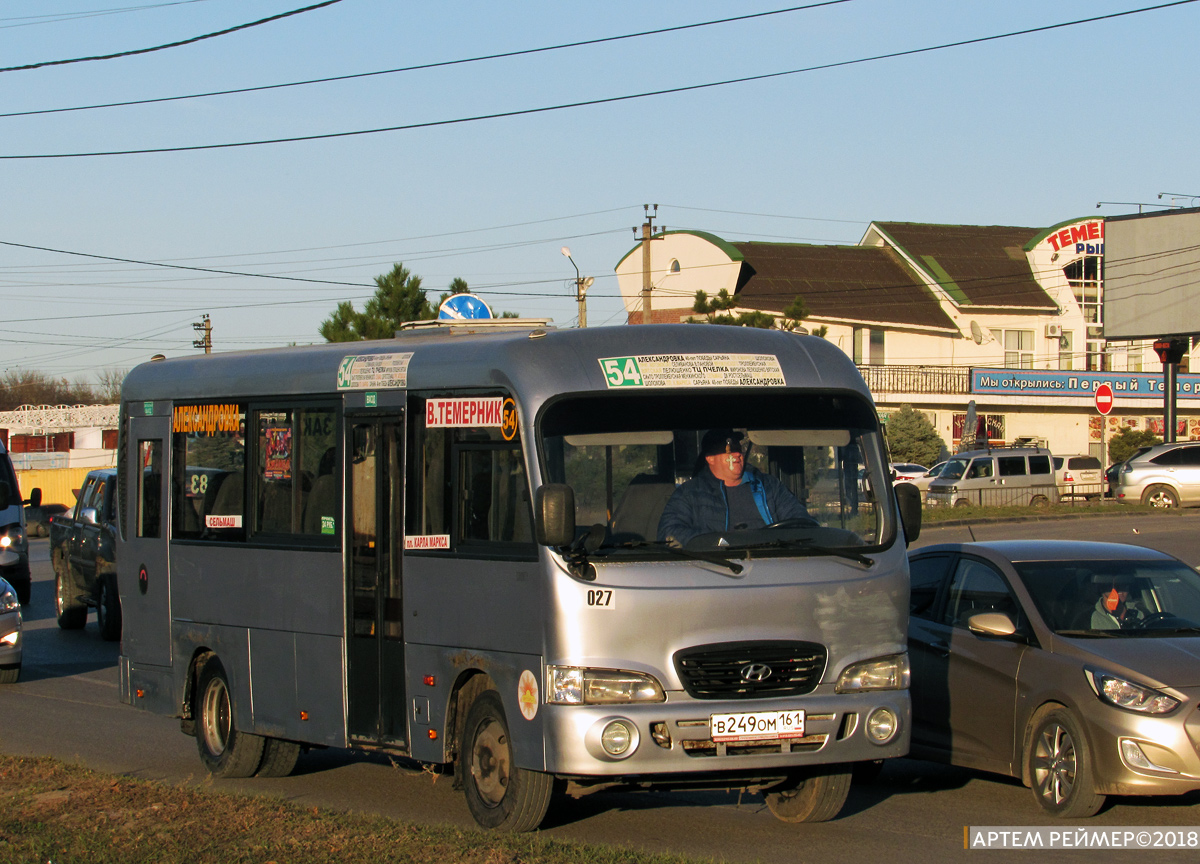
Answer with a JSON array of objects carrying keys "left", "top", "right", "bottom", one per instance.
[{"left": 455, "top": 690, "right": 554, "bottom": 832}]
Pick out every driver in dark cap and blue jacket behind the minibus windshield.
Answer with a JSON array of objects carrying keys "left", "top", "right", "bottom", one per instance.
[{"left": 659, "top": 428, "right": 809, "bottom": 545}]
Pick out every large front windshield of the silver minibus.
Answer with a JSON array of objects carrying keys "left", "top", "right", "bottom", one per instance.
[{"left": 540, "top": 390, "right": 895, "bottom": 554}]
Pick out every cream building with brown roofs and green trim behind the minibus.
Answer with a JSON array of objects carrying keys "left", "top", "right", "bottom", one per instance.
[{"left": 616, "top": 218, "right": 1200, "bottom": 463}]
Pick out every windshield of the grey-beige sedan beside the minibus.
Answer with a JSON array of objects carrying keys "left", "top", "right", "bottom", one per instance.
[{"left": 1014, "top": 560, "right": 1200, "bottom": 637}]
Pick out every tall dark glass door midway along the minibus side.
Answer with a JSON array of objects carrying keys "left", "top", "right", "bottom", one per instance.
[{"left": 346, "top": 416, "right": 408, "bottom": 743}]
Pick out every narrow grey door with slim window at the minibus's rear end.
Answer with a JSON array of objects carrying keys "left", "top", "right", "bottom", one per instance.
[{"left": 116, "top": 415, "right": 172, "bottom": 666}]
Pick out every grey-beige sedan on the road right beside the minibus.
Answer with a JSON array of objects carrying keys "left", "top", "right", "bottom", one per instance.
[{"left": 908, "top": 540, "right": 1200, "bottom": 817}]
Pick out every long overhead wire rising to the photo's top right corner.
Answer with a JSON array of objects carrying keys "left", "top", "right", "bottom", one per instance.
[{"left": 0, "top": 0, "right": 1196, "bottom": 160}]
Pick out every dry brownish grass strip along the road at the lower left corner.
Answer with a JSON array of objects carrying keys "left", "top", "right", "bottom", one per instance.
[{"left": 0, "top": 755, "right": 698, "bottom": 864}]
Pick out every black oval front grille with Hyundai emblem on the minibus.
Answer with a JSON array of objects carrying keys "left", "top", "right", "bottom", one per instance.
[{"left": 674, "top": 642, "right": 827, "bottom": 700}]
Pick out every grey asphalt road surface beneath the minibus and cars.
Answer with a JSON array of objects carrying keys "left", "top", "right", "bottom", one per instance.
[{"left": 7, "top": 512, "right": 1200, "bottom": 864}]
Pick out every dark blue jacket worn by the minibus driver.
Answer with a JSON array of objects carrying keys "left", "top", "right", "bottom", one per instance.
[{"left": 659, "top": 464, "right": 809, "bottom": 545}]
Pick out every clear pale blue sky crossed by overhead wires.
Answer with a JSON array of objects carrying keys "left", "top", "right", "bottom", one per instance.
[{"left": 0, "top": 0, "right": 1200, "bottom": 388}]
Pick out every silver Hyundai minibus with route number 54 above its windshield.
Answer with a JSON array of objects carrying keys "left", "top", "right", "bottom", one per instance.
[{"left": 116, "top": 320, "right": 920, "bottom": 830}]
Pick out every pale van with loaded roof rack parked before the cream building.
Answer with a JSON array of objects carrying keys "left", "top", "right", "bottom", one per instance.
[{"left": 925, "top": 448, "right": 1058, "bottom": 506}]
